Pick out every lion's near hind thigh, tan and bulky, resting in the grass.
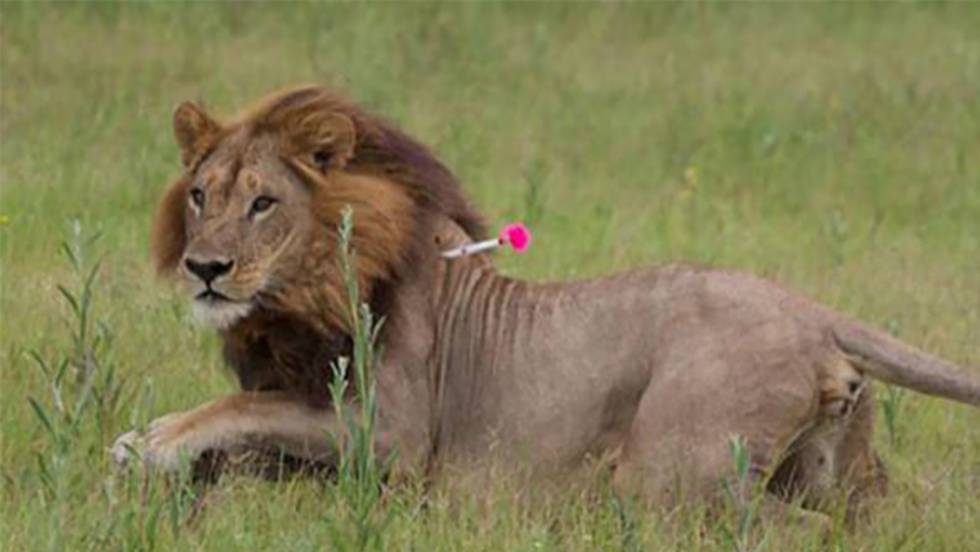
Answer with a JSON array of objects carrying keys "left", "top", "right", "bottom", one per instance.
[{"left": 614, "top": 357, "right": 816, "bottom": 507}]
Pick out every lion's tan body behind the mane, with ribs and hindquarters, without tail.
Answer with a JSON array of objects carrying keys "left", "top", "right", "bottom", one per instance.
[{"left": 362, "top": 224, "right": 881, "bottom": 503}]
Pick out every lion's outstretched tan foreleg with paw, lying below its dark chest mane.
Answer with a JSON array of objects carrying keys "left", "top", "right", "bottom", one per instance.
[{"left": 112, "top": 392, "right": 344, "bottom": 471}]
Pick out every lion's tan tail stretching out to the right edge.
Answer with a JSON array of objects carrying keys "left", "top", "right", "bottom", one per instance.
[{"left": 833, "top": 323, "right": 980, "bottom": 406}]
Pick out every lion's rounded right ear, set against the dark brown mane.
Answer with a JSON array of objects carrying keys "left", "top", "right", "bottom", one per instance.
[{"left": 287, "top": 111, "right": 357, "bottom": 172}]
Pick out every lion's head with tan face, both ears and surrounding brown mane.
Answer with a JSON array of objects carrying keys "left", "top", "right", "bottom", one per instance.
[{"left": 152, "top": 86, "right": 484, "bottom": 330}]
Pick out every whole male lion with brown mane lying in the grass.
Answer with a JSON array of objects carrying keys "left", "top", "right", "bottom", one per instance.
[{"left": 111, "top": 86, "right": 980, "bottom": 511}]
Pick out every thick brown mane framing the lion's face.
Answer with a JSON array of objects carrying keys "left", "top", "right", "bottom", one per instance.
[{"left": 145, "top": 87, "right": 485, "bottom": 403}]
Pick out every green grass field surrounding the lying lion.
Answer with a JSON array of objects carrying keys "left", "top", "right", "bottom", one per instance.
[{"left": 0, "top": 3, "right": 980, "bottom": 551}]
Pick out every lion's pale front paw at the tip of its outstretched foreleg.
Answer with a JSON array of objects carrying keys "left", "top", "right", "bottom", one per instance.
[{"left": 109, "top": 415, "right": 199, "bottom": 472}]
